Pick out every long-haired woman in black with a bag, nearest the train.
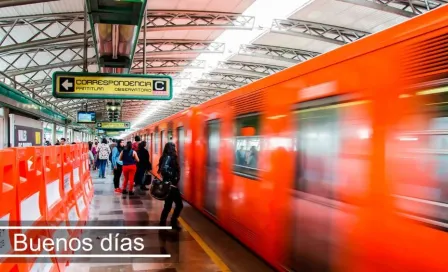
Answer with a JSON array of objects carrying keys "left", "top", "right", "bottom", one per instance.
[{"left": 157, "top": 142, "right": 184, "bottom": 230}]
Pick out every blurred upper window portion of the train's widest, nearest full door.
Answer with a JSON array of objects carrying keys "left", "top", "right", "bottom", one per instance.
[{"left": 294, "top": 100, "right": 371, "bottom": 200}]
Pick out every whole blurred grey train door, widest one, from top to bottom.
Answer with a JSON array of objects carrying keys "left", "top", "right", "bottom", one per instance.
[{"left": 289, "top": 97, "right": 370, "bottom": 272}]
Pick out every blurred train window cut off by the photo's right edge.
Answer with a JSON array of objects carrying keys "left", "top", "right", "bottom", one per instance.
[{"left": 388, "top": 86, "right": 448, "bottom": 218}]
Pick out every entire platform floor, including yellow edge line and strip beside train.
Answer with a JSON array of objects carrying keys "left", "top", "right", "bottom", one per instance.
[{"left": 66, "top": 168, "right": 273, "bottom": 272}]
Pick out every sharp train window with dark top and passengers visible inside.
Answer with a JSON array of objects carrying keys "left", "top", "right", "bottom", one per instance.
[{"left": 233, "top": 114, "right": 261, "bottom": 178}]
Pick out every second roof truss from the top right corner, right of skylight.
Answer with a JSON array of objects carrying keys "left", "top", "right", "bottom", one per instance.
[{"left": 270, "top": 19, "right": 370, "bottom": 45}]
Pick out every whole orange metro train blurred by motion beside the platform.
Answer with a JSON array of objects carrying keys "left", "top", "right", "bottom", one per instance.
[{"left": 128, "top": 7, "right": 448, "bottom": 271}]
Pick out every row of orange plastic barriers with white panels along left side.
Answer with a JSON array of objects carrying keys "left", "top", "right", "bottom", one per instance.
[{"left": 0, "top": 144, "right": 94, "bottom": 272}]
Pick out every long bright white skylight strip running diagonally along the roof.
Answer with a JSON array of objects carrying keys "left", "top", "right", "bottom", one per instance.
[{"left": 130, "top": 0, "right": 312, "bottom": 130}]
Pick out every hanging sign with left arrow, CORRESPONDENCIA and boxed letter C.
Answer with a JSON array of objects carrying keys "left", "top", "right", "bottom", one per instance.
[{"left": 53, "top": 72, "right": 173, "bottom": 100}]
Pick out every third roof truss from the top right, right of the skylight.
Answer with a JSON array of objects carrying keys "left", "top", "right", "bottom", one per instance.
[{"left": 238, "top": 44, "right": 320, "bottom": 64}]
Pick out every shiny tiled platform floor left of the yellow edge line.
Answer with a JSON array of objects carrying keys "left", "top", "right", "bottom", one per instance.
[{"left": 66, "top": 169, "right": 220, "bottom": 272}]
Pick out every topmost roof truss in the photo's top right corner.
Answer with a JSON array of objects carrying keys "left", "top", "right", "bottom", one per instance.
[{"left": 336, "top": 0, "right": 448, "bottom": 18}]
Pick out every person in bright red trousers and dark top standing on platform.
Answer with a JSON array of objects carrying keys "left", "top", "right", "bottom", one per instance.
[{"left": 120, "top": 141, "right": 139, "bottom": 195}]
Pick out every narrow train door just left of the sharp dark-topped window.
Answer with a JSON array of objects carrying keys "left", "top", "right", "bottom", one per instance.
[{"left": 204, "top": 120, "right": 220, "bottom": 216}]
